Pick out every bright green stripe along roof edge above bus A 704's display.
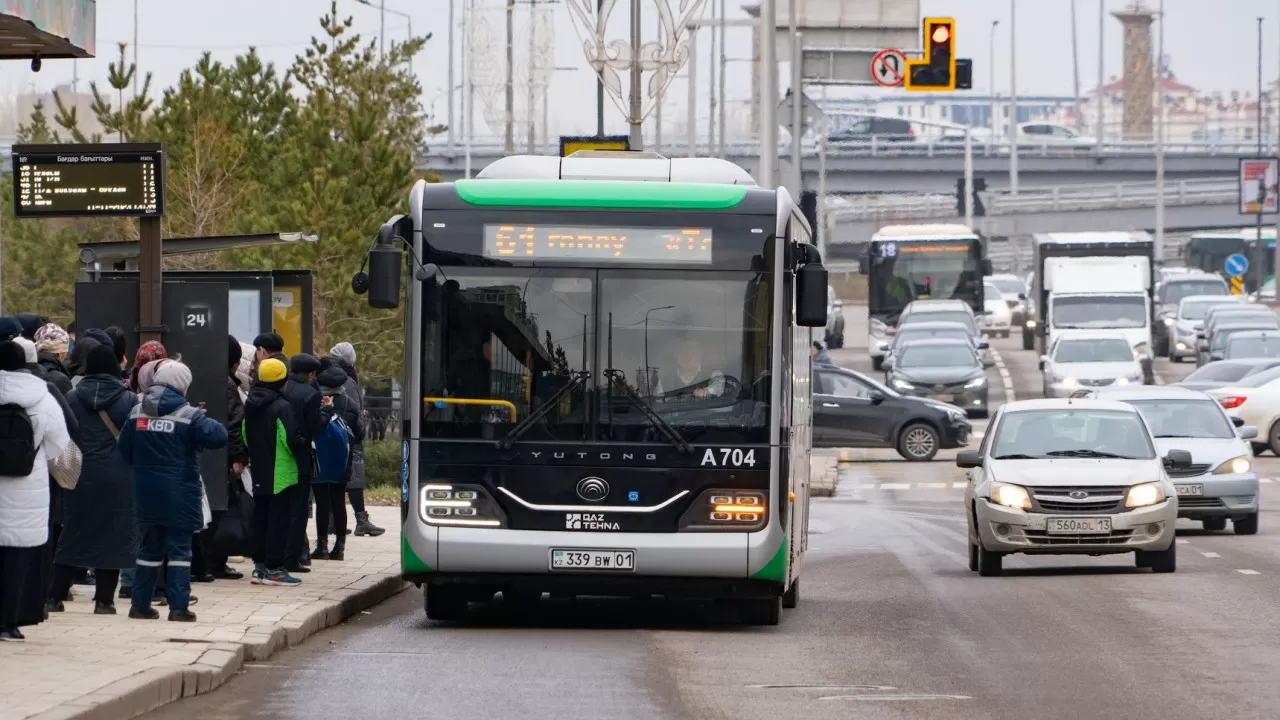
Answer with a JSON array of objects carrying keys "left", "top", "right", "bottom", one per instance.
[{"left": 453, "top": 179, "right": 746, "bottom": 210}]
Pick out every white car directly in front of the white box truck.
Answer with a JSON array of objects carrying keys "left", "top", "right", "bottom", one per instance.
[{"left": 1041, "top": 331, "right": 1142, "bottom": 397}]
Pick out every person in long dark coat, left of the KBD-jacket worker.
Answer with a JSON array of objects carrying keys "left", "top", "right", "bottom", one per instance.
[{"left": 50, "top": 345, "right": 138, "bottom": 615}]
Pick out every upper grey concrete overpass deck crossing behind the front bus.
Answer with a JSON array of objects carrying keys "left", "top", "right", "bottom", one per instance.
[{"left": 417, "top": 138, "right": 1276, "bottom": 195}]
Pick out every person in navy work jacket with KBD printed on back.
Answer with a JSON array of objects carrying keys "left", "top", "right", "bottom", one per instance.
[{"left": 118, "top": 361, "right": 227, "bottom": 623}]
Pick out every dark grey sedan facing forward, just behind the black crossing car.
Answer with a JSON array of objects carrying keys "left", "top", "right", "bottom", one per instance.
[{"left": 886, "top": 338, "right": 988, "bottom": 418}]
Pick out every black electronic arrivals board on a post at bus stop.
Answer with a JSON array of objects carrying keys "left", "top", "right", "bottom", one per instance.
[{"left": 13, "top": 146, "right": 164, "bottom": 218}]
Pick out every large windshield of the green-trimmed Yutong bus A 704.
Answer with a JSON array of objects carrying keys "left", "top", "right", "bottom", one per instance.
[{"left": 422, "top": 266, "right": 773, "bottom": 442}]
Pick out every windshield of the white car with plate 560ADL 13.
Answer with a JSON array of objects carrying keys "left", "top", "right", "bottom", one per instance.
[{"left": 991, "top": 405, "right": 1156, "bottom": 460}]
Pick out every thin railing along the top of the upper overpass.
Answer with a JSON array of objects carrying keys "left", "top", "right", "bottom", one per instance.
[{"left": 425, "top": 137, "right": 1276, "bottom": 163}]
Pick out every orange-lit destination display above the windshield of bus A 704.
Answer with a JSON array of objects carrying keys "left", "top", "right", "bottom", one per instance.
[{"left": 484, "top": 224, "right": 712, "bottom": 265}]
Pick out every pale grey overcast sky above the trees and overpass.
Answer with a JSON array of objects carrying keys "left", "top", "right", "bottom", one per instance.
[{"left": 0, "top": 0, "right": 1280, "bottom": 135}]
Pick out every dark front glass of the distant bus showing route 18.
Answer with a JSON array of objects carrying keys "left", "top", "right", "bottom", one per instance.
[{"left": 867, "top": 238, "right": 983, "bottom": 315}]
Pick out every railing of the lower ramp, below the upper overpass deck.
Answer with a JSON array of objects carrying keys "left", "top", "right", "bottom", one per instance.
[{"left": 831, "top": 178, "right": 1239, "bottom": 222}]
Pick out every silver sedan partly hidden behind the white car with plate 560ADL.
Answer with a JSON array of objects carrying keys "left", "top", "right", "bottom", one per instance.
[{"left": 1098, "top": 386, "right": 1258, "bottom": 536}]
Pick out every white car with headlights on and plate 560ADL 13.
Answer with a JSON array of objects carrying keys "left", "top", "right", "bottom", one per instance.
[{"left": 956, "top": 398, "right": 1192, "bottom": 575}]
